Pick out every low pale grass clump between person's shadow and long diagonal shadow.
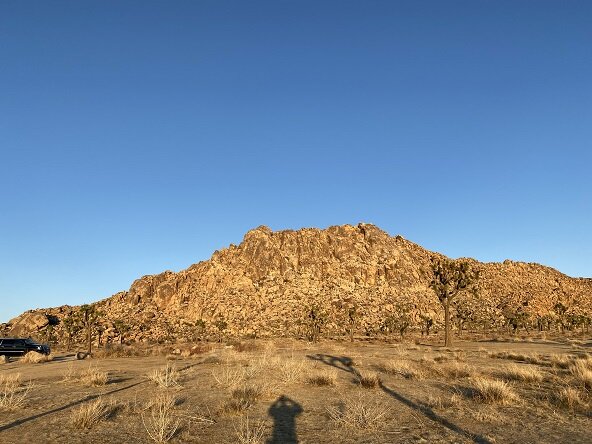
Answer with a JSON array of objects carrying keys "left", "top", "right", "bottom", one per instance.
[{"left": 327, "top": 397, "right": 389, "bottom": 430}]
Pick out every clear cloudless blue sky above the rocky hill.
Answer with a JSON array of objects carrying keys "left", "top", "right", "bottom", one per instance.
[{"left": 0, "top": 0, "right": 592, "bottom": 321}]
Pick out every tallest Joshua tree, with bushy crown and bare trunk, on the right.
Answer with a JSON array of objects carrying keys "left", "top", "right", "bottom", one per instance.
[{"left": 430, "top": 259, "right": 479, "bottom": 347}]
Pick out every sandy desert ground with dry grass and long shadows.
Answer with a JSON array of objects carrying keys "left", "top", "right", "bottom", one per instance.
[{"left": 0, "top": 337, "right": 592, "bottom": 444}]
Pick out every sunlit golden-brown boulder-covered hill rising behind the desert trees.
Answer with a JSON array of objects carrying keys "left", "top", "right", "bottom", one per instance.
[{"left": 3, "top": 224, "right": 592, "bottom": 341}]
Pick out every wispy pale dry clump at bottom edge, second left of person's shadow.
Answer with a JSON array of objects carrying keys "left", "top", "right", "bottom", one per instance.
[{"left": 142, "top": 393, "right": 180, "bottom": 443}]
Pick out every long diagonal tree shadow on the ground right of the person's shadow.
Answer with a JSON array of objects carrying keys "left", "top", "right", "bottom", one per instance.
[{"left": 307, "top": 353, "right": 491, "bottom": 444}]
